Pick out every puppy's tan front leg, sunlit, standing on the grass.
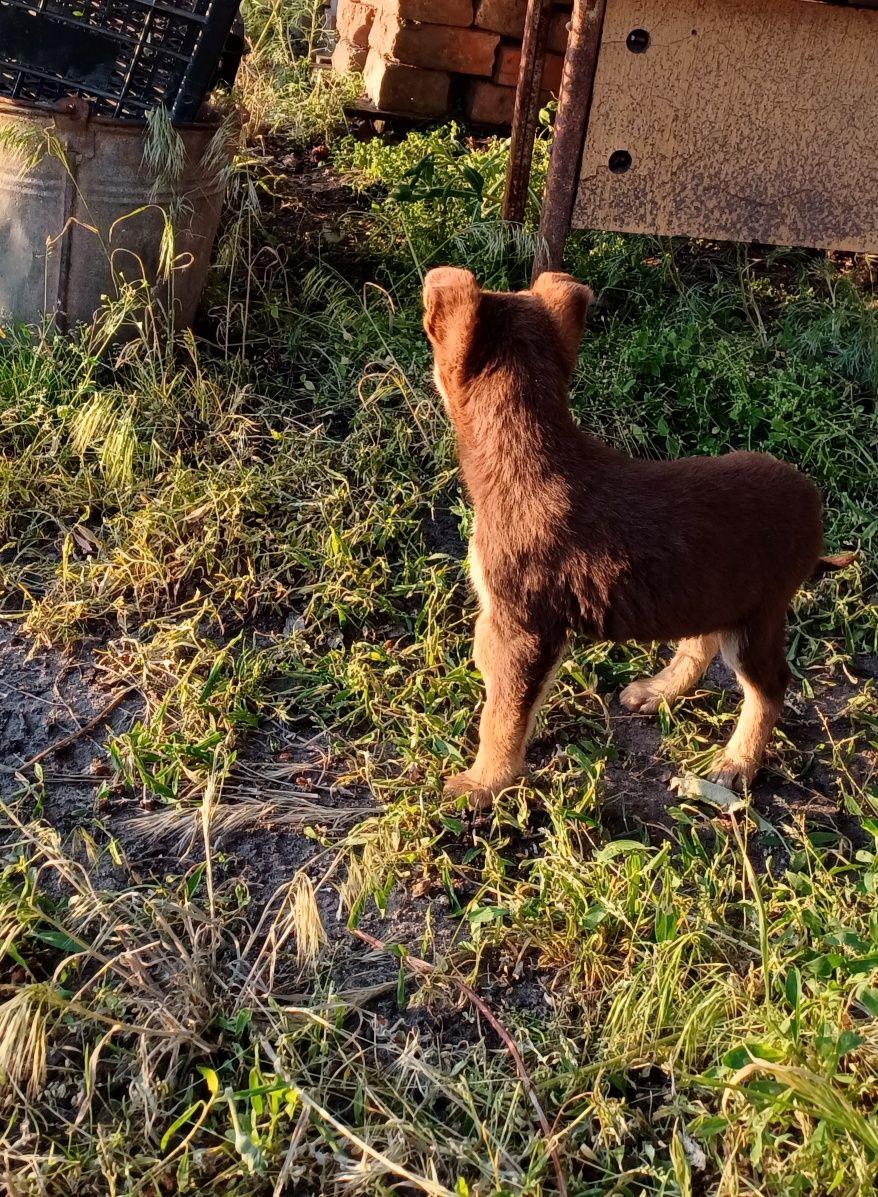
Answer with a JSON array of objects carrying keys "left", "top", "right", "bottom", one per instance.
[{"left": 445, "top": 610, "right": 566, "bottom": 809}]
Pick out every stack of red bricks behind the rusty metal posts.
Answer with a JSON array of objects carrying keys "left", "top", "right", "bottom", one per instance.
[{"left": 333, "top": 0, "right": 571, "bottom": 124}]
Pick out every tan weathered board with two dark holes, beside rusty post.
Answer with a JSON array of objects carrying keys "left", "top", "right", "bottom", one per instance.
[{"left": 573, "top": 0, "right": 878, "bottom": 253}]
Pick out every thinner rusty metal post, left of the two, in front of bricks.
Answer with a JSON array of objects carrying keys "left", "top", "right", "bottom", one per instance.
[{"left": 504, "top": 0, "right": 554, "bottom": 224}]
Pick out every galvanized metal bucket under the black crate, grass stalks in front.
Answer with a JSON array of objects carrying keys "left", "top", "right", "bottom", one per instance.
[{"left": 0, "top": 99, "right": 232, "bottom": 330}]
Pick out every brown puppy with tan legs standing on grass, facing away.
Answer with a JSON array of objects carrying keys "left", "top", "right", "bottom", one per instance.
[{"left": 423, "top": 267, "right": 853, "bottom": 806}]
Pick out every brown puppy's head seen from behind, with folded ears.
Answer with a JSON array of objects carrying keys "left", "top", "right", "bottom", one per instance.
[{"left": 423, "top": 266, "right": 593, "bottom": 424}]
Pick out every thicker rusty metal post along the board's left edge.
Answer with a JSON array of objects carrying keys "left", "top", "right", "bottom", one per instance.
[{"left": 532, "top": 0, "right": 606, "bottom": 279}]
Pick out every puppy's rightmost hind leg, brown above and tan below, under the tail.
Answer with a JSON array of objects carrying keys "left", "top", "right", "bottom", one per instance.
[{"left": 711, "top": 612, "right": 789, "bottom": 789}]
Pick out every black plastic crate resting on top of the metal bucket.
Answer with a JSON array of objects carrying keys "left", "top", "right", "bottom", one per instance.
[{"left": 0, "top": 0, "right": 239, "bottom": 121}]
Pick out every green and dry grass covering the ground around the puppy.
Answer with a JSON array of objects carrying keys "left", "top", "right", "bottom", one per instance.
[{"left": 0, "top": 21, "right": 878, "bottom": 1197}]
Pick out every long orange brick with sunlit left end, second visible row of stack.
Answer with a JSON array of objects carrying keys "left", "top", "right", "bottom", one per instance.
[{"left": 368, "top": 13, "right": 500, "bottom": 75}]
